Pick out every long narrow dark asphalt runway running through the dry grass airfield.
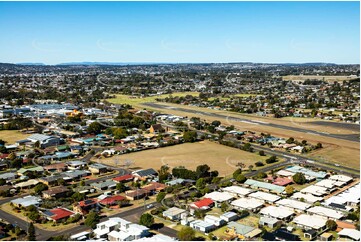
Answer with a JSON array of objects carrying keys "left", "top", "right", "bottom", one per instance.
[{"left": 142, "top": 103, "right": 360, "bottom": 142}]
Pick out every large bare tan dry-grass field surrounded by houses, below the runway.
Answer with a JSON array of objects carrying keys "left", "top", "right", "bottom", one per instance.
[{"left": 95, "top": 141, "right": 267, "bottom": 176}]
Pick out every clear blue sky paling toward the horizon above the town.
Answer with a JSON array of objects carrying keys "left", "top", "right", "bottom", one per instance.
[{"left": 0, "top": 2, "right": 360, "bottom": 64}]
